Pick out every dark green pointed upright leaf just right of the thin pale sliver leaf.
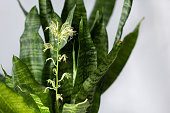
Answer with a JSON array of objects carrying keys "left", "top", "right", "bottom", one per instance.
[{"left": 74, "top": 18, "right": 97, "bottom": 96}]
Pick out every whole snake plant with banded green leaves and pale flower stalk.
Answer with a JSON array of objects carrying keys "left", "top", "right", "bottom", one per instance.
[{"left": 0, "top": 0, "right": 141, "bottom": 113}]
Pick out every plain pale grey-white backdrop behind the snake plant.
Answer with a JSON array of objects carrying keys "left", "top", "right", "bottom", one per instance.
[{"left": 0, "top": 0, "right": 170, "bottom": 113}]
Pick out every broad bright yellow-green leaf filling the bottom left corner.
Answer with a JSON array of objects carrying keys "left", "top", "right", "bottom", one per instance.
[{"left": 0, "top": 82, "right": 36, "bottom": 113}]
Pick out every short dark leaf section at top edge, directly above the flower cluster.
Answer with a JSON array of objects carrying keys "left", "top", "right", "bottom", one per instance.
[{"left": 61, "top": 0, "right": 76, "bottom": 23}]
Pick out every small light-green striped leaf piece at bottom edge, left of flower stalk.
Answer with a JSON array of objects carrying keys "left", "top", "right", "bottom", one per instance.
[{"left": 30, "top": 94, "right": 50, "bottom": 113}]
